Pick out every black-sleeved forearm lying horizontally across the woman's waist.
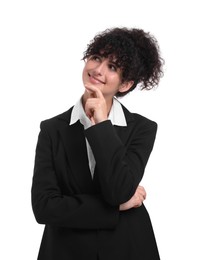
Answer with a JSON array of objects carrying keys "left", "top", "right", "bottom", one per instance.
[{"left": 32, "top": 183, "right": 119, "bottom": 229}]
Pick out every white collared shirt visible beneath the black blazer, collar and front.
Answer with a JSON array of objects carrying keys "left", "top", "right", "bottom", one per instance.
[{"left": 69, "top": 98, "right": 127, "bottom": 178}]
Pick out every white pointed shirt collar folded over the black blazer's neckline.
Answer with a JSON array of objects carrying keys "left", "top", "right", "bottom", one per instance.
[{"left": 69, "top": 98, "right": 127, "bottom": 128}]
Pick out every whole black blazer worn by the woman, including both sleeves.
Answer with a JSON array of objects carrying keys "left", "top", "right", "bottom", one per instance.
[{"left": 32, "top": 106, "right": 159, "bottom": 260}]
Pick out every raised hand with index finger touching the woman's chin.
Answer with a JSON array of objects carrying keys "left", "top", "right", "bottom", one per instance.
[{"left": 84, "top": 85, "right": 108, "bottom": 124}]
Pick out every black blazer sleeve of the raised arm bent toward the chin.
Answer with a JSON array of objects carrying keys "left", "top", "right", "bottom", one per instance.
[{"left": 85, "top": 119, "right": 157, "bottom": 205}]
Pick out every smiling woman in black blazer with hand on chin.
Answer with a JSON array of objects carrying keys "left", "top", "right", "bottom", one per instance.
[{"left": 32, "top": 28, "right": 162, "bottom": 260}]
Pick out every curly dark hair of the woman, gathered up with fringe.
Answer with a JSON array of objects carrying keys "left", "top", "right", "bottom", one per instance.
[{"left": 83, "top": 27, "right": 164, "bottom": 97}]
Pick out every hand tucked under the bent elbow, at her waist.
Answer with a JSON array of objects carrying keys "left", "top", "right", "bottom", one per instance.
[{"left": 119, "top": 186, "right": 146, "bottom": 211}]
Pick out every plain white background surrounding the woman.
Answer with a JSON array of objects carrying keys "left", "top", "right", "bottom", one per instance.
[{"left": 0, "top": 0, "right": 202, "bottom": 260}]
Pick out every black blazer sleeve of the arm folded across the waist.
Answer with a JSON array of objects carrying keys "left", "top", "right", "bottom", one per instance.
[{"left": 31, "top": 121, "right": 119, "bottom": 229}]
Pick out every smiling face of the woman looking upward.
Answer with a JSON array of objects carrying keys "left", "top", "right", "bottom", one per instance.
[{"left": 83, "top": 55, "right": 122, "bottom": 98}]
